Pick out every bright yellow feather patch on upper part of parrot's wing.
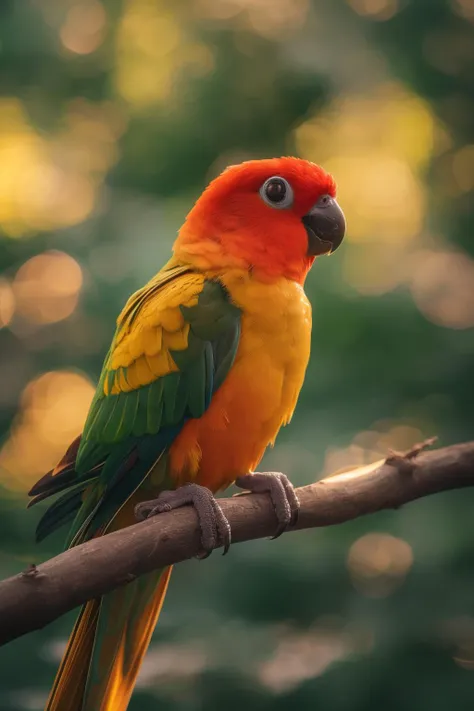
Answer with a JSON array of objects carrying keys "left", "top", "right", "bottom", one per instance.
[{"left": 104, "top": 272, "right": 204, "bottom": 395}]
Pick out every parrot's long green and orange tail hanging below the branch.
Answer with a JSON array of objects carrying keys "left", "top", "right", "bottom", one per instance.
[{"left": 45, "top": 567, "right": 172, "bottom": 711}]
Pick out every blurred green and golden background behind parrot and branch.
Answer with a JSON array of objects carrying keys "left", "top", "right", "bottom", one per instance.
[{"left": 0, "top": 0, "right": 474, "bottom": 711}]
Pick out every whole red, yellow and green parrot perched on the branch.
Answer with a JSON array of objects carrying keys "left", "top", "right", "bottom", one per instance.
[{"left": 29, "top": 156, "right": 346, "bottom": 711}]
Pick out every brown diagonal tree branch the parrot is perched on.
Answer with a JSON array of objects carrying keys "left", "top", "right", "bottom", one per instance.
[{"left": 0, "top": 440, "right": 474, "bottom": 644}]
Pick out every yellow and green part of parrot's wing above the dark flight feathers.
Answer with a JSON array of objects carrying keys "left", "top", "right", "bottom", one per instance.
[{"left": 77, "top": 264, "right": 240, "bottom": 471}]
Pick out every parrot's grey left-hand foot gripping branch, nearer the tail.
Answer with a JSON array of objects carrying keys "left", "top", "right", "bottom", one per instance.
[{"left": 135, "top": 484, "right": 231, "bottom": 558}]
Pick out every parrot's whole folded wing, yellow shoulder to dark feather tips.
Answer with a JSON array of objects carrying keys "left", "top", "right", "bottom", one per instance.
[{"left": 30, "top": 260, "right": 240, "bottom": 543}]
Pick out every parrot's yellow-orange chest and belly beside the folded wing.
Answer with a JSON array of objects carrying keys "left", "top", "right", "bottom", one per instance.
[{"left": 170, "top": 272, "right": 311, "bottom": 491}]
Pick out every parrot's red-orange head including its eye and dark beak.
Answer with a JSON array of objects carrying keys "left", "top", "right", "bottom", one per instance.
[{"left": 175, "top": 158, "right": 345, "bottom": 282}]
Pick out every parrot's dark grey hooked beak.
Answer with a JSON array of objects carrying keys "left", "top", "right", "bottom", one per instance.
[{"left": 302, "top": 195, "right": 346, "bottom": 257}]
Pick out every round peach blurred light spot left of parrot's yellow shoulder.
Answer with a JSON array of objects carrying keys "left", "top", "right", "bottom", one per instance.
[{"left": 13, "top": 252, "right": 82, "bottom": 324}]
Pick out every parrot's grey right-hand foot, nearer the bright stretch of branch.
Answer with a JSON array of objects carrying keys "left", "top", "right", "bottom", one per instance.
[{"left": 235, "top": 472, "right": 300, "bottom": 538}]
